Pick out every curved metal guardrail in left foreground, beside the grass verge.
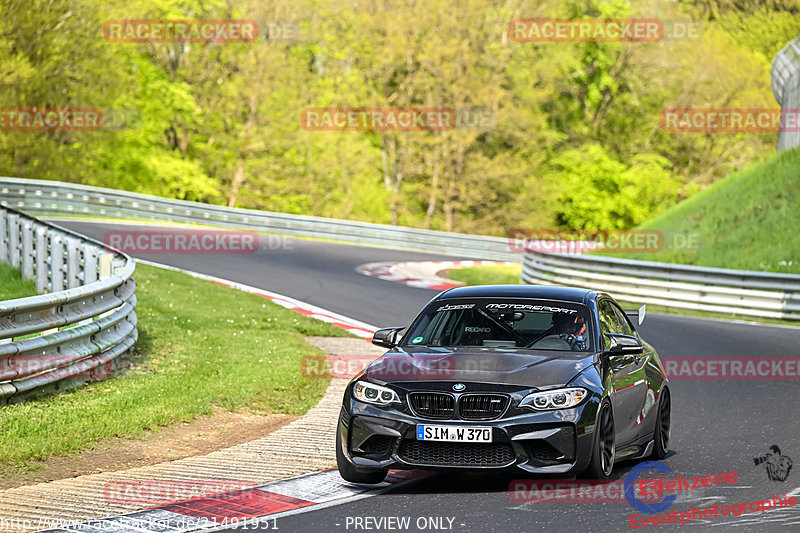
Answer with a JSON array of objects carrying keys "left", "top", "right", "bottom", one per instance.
[{"left": 0, "top": 207, "right": 138, "bottom": 403}]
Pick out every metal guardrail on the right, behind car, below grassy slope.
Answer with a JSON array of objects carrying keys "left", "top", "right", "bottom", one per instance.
[{"left": 522, "top": 252, "right": 800, "bottom": 320}]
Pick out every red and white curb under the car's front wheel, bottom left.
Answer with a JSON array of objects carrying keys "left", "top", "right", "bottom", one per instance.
[{"left": 34, "top": 470, "right": 430, "bottom": 533}]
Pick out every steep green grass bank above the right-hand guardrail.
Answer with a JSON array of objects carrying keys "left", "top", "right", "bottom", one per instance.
[{"left": 615, "top": 149, "right": 800, "bottom": 273}]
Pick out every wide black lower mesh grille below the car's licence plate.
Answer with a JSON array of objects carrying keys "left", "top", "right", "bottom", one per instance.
[{"left": 399, "top": 439, "right": 516, "bottom": 466}]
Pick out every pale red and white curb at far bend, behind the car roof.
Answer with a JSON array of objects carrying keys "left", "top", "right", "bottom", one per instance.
[{"left": 356, "top": 261, "right": 516, "bottom": 291}]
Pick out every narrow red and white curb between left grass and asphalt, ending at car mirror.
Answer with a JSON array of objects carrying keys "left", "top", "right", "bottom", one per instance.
[{"left": 136, "top": 259, "right": 378, "bottom": 339}]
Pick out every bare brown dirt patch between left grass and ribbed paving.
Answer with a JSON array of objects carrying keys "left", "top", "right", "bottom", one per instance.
[{"left": 0, "top": 411, "right": 299, "bottom": 490}]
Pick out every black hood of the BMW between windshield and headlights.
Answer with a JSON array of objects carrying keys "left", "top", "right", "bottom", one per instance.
[{"left": 364, "top": 347, "right": 595, "bottom": 388}]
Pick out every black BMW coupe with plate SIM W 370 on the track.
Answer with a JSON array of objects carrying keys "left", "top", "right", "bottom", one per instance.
[{"left": 336, "top": 285, "right": 670, "bottom": 483}]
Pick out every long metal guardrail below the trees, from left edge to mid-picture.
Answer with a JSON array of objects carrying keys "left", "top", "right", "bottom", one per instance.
[{"left": 0, "top": 177, "right": 519, "bottom": 261}]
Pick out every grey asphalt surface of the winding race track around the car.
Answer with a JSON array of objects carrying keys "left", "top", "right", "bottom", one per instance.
[{"left": 60, "top": 221, "right": 800, "bottom": 532}]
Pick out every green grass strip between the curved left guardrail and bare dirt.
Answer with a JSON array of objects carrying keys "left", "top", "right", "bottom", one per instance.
[{"left": 0, "top": 265, "right": 347, "bottom": 476}]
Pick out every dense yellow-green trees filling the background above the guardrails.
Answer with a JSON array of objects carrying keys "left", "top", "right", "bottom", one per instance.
[{"left": 0, "top": 0, "right": 800, "bottom": 234}]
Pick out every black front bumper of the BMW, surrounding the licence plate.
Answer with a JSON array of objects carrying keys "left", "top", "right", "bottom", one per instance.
[{"left": 339, "top": 397, "right": 599, "bottom": 474}]
